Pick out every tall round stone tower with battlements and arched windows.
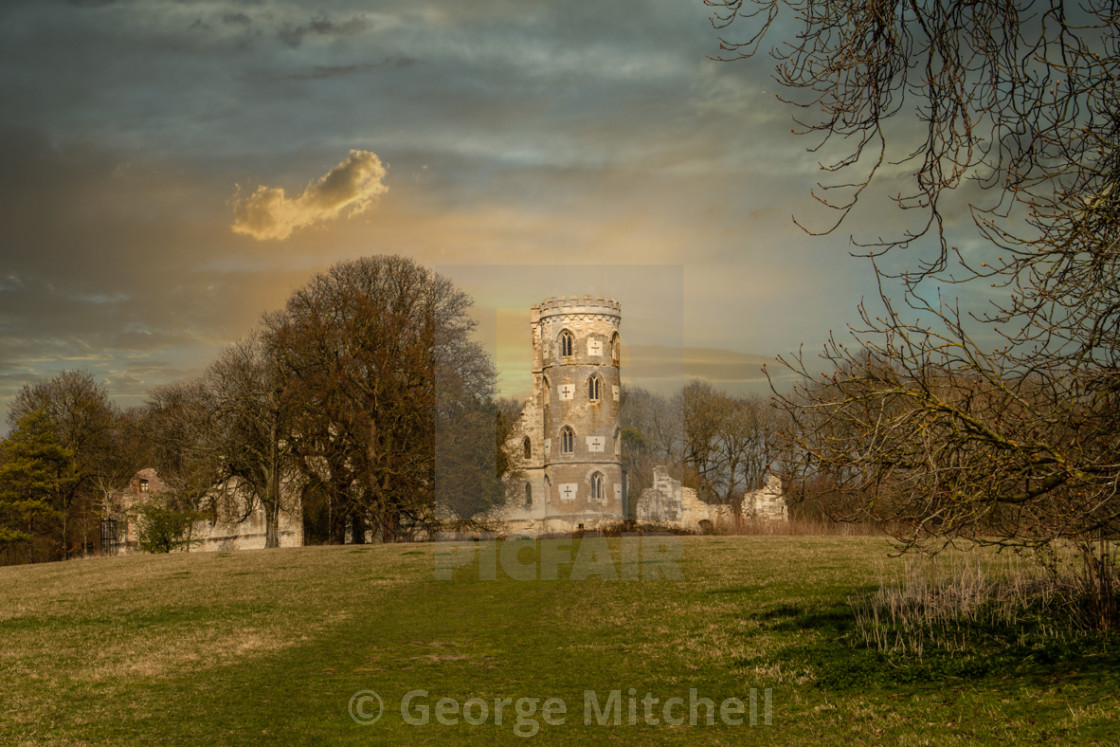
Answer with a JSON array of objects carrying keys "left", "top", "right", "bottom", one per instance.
[{"left": 508, "top": 296, "right": 626, "bottom": 531}]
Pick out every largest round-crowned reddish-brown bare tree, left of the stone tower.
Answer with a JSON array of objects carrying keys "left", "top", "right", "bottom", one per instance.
[{"left": 267, "top": 256, "right": 493, "bottom": 541}]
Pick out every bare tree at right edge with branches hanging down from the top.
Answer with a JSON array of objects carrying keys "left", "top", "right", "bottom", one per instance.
[{"left": 706, "top": 0, "right": 1120, "bottom": 613}]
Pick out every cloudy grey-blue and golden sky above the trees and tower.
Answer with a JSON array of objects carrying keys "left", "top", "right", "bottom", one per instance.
[{"left": 0, "top": 0, "right": 891, "bottom": 425}]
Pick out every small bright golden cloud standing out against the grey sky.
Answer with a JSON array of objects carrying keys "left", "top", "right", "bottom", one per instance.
[{"left": 233, "top": 150, "right": 389, "bottom": 241}]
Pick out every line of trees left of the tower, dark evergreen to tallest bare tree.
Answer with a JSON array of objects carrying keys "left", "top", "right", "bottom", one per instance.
[{"left": 0, "top": 256, "right": 516, "bottom": 562}]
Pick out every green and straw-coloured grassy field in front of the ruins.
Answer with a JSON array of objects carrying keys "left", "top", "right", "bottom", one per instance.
[{"left": 0, "top": 536, "right": 1120, "bottom": 745}]
